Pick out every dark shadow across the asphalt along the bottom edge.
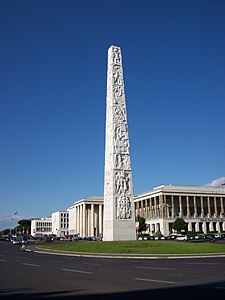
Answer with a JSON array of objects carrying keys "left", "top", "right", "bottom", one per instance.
[{"left": 0, "top": 282, "right": 225, "bottom": 300}]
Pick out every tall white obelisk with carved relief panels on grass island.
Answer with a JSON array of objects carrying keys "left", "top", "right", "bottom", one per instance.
[{"left": 103, "top": 46, "right": 136, "bottom": 241}]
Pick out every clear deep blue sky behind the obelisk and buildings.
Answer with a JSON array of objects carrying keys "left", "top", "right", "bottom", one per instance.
[{"left": 0, "top": 0, "right": 225, "bottom": 227}]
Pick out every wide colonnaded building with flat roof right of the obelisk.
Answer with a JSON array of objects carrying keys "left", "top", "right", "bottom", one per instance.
[{"left": 135, "top": 185, "right": 225, "bottom": 235}]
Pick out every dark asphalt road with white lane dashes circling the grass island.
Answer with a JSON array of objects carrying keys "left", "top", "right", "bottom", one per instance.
[{"left": 0, "top": 241, "right": 225, "bottom": 300}]
